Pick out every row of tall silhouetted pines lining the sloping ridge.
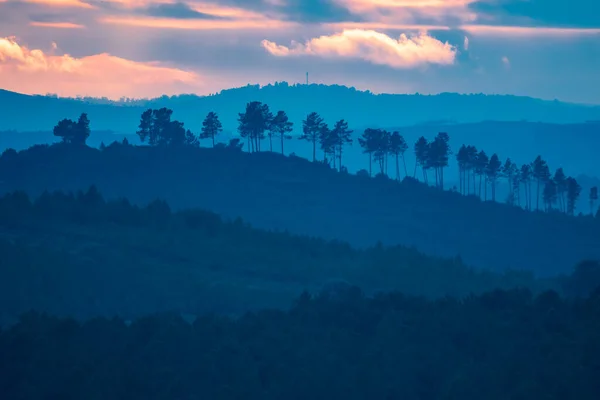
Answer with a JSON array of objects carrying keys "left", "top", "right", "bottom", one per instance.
[{"left": 49, "top": 101, "right": 600, "bottom": 219}]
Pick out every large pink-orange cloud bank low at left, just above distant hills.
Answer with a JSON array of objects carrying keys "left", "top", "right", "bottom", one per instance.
[{"left": 0, "top": 37, "right": 201, "bottom": 98}]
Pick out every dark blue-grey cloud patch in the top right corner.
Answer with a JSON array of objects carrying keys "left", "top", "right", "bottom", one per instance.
[{"left": 470, "top": 0, "right": 600, "bottom": 28}]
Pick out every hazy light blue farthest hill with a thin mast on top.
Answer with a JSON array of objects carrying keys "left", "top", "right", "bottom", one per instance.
[{"left": 0, "top": 83, "right": 600, "bottom": 133}]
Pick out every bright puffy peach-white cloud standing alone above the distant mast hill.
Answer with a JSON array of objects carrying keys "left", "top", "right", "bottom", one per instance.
[{"left": 262, "top": 29, "right": 456, "bottom": 69}]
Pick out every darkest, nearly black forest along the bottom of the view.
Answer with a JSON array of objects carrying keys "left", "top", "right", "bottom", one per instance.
[{"left": 0, "top": 288, "right": 600, "bottom": 400}]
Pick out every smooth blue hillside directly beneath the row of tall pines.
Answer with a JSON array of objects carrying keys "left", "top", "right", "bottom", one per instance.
[{"left": 0, "top": 145, "right": 600, "bottom": 276}]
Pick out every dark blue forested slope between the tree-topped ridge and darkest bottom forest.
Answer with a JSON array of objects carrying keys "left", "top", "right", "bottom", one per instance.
[{"left": 0, "top": 186, "right": 564, "bottom": 326}]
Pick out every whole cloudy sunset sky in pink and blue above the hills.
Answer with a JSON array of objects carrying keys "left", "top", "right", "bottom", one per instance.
[{"left": 0, "top": 0, "right": 600, "bottom": 104}]
